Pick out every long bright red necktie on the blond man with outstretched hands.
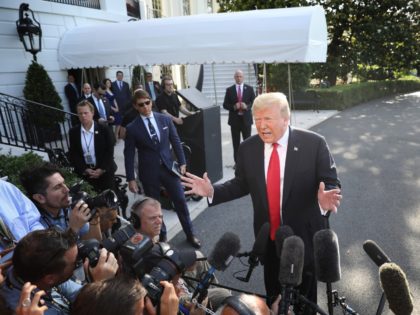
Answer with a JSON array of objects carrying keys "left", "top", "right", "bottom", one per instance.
[{"left": 267, "top": 143, "right": 281, "bottom": 241}]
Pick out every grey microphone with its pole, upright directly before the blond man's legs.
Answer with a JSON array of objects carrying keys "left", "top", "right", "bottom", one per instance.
[{"left": 276, "top": 236, "right": 305, "bottom": 315}]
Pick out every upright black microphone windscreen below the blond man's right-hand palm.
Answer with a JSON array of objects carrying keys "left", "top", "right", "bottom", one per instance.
[{"left": 313, "top": 229, "right": 341, "bottom": 283}]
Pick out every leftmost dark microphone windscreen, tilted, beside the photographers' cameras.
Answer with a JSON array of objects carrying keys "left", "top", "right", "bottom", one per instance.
[{"left": 208, "top": 232, "right": 241, "bottom": 270}]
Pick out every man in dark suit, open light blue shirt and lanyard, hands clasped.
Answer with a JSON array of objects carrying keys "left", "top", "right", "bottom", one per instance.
[{"left": 69, "top": 100, "right": 117, "bottom": 192}]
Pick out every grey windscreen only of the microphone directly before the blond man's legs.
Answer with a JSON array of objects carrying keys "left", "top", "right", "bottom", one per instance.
[{"left": 279, "top": 235, "right": 305, "bottom": 287}]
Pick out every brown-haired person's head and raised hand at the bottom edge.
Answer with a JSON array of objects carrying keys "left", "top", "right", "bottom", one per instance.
[{"left": 71, "top": 275, "right": 178, "bottom": 315}]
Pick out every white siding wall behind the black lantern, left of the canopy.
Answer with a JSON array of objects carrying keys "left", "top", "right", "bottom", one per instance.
[{"left": 0, "top": 0, "right": 128, "bottom": 111}]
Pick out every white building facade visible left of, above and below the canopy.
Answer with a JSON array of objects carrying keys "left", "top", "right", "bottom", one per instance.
[{"left": 0, "top": 0, "right": 217, "bottom": 112}]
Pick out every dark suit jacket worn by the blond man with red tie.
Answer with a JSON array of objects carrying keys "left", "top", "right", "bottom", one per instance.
[{"left": 211, "top": 128, "right": 340, "bottom": 264}]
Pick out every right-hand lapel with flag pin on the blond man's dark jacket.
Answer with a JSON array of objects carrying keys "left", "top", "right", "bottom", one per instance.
[{"left": 282, "top": 127, "right": 300, "bottom": 205}]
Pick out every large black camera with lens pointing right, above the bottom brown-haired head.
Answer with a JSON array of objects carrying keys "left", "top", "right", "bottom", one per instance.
[{"left": 120, "top": 236, "right": 197, "bottom": 305}]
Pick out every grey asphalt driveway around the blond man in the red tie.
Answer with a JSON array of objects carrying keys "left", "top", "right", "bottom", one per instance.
[{"left": 170, "top": 92, "right": 420, "bottom": 314}]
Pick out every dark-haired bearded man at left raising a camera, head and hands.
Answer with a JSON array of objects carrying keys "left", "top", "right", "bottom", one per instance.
[{"left": 20, "top": 163, "right": 101, "bottom": 240}]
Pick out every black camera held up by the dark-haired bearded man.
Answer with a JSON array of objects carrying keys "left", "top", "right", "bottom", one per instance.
[{"left": 69, "top": 181, "right": 118, "bottom": 218}]
